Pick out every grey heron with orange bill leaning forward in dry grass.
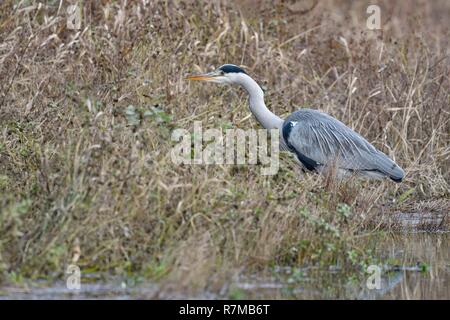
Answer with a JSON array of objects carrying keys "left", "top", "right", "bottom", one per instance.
[{"left": 187, "top": 64, "right": 405, "bottom": 182}]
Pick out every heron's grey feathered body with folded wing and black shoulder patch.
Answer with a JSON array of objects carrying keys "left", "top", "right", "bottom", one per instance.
[{"left": 283, "top": 109, "right": 404, "bottom": 181}]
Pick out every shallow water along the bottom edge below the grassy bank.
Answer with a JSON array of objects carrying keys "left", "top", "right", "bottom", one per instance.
[{"left": 0, "top": 232, "right": 450, "bottom": 299}]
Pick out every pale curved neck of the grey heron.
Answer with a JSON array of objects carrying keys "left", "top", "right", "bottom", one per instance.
[{"left": 237, "top": 73, "right": 283, "bottom": 129}]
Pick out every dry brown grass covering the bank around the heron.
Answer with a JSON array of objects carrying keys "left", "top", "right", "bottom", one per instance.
[{"left": 0, "top": 0, "right": 450, "bottom": 296}]
